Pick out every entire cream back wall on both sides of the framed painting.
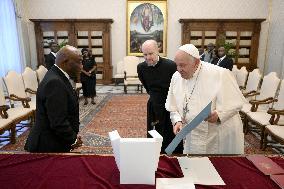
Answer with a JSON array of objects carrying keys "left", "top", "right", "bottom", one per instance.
[{"left": 25, "top": 0, "right": 278, "bottom": 77}]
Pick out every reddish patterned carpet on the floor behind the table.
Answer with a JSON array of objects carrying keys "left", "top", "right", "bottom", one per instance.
[{"left": 0, "top": 93, "right": 275, "bottom": 154}]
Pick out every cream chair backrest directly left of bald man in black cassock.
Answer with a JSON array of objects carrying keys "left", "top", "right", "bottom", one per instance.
[{"left": 123, "top": 56, "right": 139, "bottom": 77}]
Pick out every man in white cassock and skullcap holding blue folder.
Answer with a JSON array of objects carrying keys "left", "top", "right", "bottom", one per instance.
[{"left": 165, "top": 44, "right": 246, "bottom": 154}]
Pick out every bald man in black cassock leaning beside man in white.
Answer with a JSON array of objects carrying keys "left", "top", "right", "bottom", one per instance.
[{"left": 137, "top": 40, "right": 183, "bottom": 154}]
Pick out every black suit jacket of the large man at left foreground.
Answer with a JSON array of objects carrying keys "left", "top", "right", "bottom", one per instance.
[{"left": 25, "top": 66, "right": 79, "bottom": 152}]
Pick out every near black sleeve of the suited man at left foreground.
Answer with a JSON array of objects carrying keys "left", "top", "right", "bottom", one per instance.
[{"left": 45, "top": 79, "right": 77, "bottom": 145}]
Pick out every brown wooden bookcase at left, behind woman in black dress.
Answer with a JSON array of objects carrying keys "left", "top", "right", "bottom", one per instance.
[{"left": 31, "top": 19, "right": 113, "bottom": 84}]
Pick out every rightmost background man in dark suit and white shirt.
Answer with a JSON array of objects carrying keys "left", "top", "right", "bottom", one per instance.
[{"left": 212, "top": 47, "right": 234, "bottom": 71}]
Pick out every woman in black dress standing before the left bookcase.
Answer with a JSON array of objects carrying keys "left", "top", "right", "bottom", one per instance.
[{"left": 81, "top": 48, "right": 97, "bottom": 105}]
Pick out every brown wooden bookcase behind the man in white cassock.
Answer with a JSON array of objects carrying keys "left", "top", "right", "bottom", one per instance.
[{"left": 179, "top": 19, "right": 264, "bottom": 71}]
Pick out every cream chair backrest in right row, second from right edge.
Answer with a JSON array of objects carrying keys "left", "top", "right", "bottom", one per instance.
[{"left": 256, "top": 72, "right": 280, "bottom": 99}]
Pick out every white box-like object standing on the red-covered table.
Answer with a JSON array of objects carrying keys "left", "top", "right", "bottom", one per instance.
[{"left": 109, "top": 130, "right": 163, "bottom": 185}]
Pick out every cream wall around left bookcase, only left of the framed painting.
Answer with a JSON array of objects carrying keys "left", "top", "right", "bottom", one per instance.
[{"left": 26, "top": 0, "right": 126, "bottom": 75}]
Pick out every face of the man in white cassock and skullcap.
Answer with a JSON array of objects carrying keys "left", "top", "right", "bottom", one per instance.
[{"left": 175, "top": 50, "right": 198, "bottom": 79}]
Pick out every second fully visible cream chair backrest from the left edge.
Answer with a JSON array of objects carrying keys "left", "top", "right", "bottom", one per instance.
[{"left": 22, "top": 67, "right": 38, "bottom": 91}]
